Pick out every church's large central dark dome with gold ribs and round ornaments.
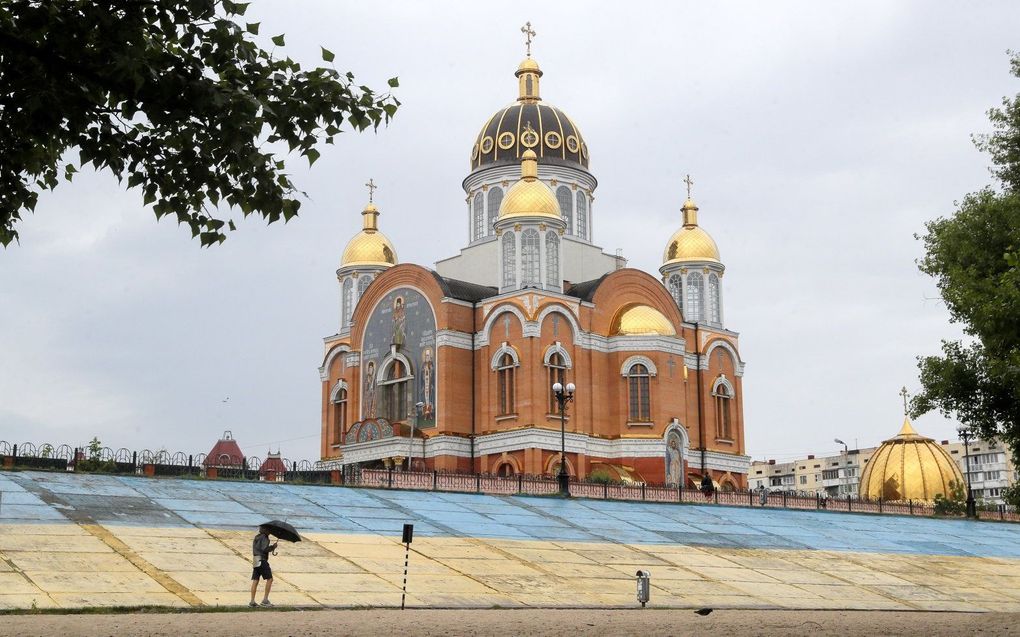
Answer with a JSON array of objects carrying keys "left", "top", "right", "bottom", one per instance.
[{"left": 471, "top": 57, "right": 589, "bottom": 170}]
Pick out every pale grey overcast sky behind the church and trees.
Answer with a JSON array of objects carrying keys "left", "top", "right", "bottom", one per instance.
[{"left": 0, "top": 0, "right": 1020, "bottom": 460}]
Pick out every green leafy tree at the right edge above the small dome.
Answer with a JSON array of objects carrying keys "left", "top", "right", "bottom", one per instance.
[{"left": 911, "top": 53, "right": 1020, "bottom": 459}]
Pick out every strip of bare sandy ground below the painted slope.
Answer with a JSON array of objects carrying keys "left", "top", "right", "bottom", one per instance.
[{"left": 0, "top": 608, "right": 1020, "bottom": 637}]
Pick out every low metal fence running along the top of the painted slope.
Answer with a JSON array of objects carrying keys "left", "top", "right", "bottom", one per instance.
[{"left": 0, "top": 440, "right": 1020, "bottom": 522}]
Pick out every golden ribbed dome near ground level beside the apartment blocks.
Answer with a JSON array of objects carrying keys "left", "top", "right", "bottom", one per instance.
[{"left": 860, "top": 418, "right": 964, "bottom": 500}]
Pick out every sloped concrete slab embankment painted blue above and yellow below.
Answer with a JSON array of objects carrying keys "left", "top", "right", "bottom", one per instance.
[{"left": 0, "top": 472, "right": 1020, "bottom": 612}]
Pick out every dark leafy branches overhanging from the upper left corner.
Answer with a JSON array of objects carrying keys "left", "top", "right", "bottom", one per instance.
[{"left": 0, "top": 0, "right": 400, "bottom": 246}]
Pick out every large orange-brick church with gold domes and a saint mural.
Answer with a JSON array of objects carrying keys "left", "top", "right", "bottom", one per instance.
[{"left": 319, "top": 29, "right": 750, "bottom": 489}]
